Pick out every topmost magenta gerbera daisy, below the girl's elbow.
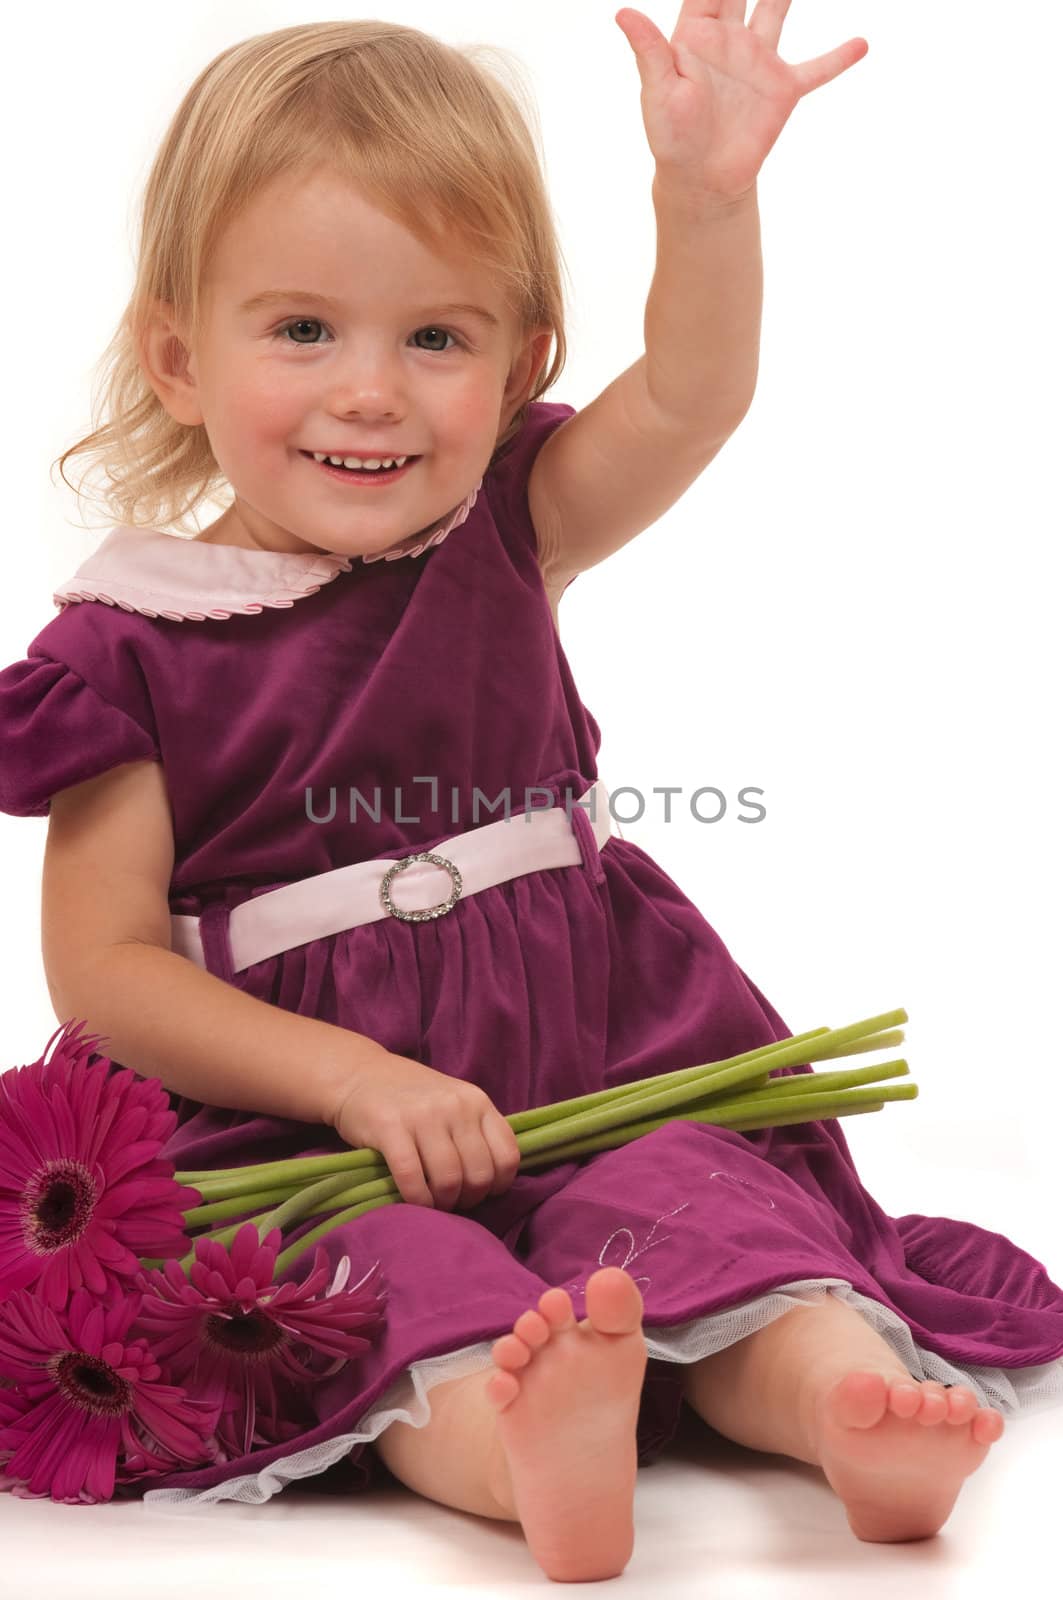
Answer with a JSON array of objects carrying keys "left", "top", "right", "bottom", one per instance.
[{"left": 0, "top": 1021, "right": 202, "bottom": 1310}]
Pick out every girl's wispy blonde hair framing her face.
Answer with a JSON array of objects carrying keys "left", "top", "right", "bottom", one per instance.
[{"left": 53, "top": 19, "right": 567, "bottom": 533}]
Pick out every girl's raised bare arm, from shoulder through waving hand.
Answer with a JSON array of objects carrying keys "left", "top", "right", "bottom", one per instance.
[{"left": 528, "top": 0, "right": 868, "bottom": 590}]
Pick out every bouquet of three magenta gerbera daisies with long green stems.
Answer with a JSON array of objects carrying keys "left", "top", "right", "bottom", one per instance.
[{"left": 0, "top": 1010, "right": 917, "bottom": 1504}]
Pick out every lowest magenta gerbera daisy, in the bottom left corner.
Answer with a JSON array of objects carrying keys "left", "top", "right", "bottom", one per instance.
[{"left": 0, "top": 1290, "right": 224, "bottom": 1506}]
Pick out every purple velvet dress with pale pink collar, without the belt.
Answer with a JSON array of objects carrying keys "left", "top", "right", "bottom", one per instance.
[{"left": 0, "top": 402, "right": 1063, "bottom": 1502}]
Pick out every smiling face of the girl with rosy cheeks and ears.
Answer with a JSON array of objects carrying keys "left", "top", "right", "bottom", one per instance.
[{"left": 147, "top": 170, "right": 551, "bottom": 555}]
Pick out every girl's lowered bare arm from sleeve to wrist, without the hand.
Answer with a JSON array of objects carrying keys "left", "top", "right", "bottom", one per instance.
[{"left": 42, "top": 762, "right": 387, "bottom": 1125}]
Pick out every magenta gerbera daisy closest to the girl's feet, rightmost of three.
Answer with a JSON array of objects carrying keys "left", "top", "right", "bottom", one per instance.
[{"left": 138, "top": 1222, "right": 384, "bottom": 1456}]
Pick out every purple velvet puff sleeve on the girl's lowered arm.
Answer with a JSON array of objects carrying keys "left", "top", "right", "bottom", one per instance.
[{"left": 0, "top": 646, "right": 160, "bottom": 816}]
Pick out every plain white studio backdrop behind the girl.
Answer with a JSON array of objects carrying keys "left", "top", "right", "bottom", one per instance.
[{"left": 0, "top": 0, "right": 1063, "bottom": 1587}]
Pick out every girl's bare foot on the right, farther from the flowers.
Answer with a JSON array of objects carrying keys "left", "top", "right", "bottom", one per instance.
[{"left": 816, "top": 1371, "right": 1004, "bottom": 1544}]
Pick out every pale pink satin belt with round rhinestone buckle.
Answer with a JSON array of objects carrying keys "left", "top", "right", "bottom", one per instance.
[{"left": 170, "top": 778, "right": 623, "bottom": 973}]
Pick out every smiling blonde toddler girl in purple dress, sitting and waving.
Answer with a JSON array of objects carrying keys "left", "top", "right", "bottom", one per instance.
[{"left": 0, "top": 12, "right": 1063, "bottom": 1581}]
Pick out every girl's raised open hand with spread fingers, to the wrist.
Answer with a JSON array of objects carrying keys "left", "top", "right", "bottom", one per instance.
[{"left": 615, "top": 0, "right": 868, "bottom": 198}]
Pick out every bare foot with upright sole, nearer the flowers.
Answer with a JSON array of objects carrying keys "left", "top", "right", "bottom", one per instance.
[{"left": 485, "top": 1267, "right": 647, "bottom": 1582}]
